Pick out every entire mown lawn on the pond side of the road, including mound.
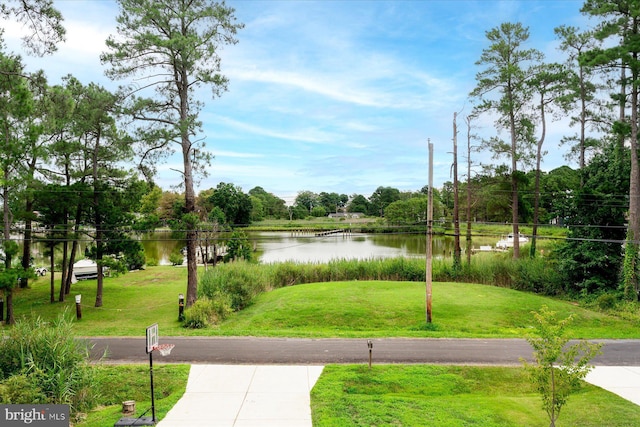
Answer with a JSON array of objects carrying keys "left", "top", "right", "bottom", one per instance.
[{"left": 15, "top": 267, "right": 640, "bottom": 339}]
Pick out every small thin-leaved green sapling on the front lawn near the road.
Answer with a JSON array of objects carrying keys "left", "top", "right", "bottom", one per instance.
[{"left": 523, "top": 306, "right": 602, "bottom": 427}]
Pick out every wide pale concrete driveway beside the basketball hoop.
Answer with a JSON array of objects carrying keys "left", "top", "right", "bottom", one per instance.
[{"left": 157, "top": 365, "right": 323, "bottom": 427}]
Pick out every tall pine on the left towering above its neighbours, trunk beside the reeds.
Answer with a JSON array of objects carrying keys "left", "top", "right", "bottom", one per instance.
[{"left": 101, "top": 0, "right": 243, "bottom": 307}]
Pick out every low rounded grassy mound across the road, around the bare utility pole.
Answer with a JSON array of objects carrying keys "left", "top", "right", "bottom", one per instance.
[{"left": 218, "top": 281, "right": 640, "bottom": 338}]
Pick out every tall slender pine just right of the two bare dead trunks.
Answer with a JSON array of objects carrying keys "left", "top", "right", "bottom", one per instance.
[{"left": 471, "top": 23, "right": 542, "bottom": 259}]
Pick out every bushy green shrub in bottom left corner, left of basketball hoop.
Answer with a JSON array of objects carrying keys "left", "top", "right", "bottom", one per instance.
[{"left": 0, "top": 313, "right": 97, "bottom": 412}]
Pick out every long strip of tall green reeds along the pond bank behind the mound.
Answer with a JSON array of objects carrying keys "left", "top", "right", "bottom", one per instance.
[{"left": 199, "top": 254, "right": 561, "bottom": 318}]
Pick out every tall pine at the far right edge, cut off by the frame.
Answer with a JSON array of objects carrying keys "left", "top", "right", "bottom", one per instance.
[{"left": 582, "top": 0, "right": 640, "bottom": 299}]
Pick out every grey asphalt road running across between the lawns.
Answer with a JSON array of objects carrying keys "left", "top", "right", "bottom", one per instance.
[{"left": 87, "top": 337, "right": 640, "bottom": 366}]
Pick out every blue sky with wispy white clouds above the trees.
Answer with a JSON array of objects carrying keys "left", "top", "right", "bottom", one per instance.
[{"left": 0, "top": 0, "right": 588, "bottom": 204}]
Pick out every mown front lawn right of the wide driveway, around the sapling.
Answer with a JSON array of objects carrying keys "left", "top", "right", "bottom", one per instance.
[{"left": 311, "top": 365, "right": 640, "bottom": 427}]
